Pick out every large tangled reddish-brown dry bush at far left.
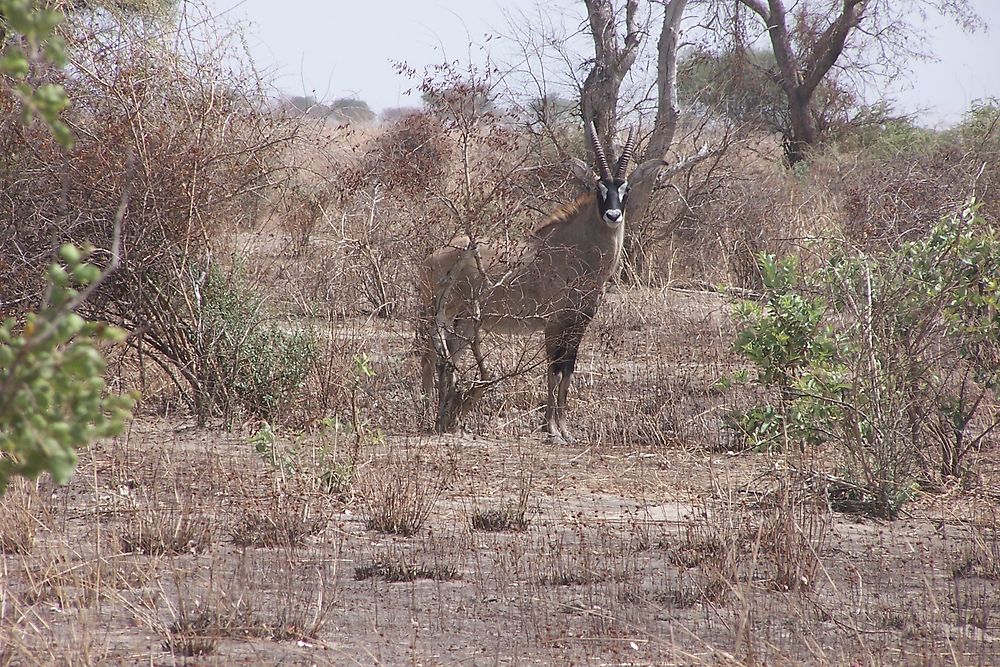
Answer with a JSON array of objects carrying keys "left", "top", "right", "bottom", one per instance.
[{"left": 0, "top": 6, "right": 295, "bottom": 417}]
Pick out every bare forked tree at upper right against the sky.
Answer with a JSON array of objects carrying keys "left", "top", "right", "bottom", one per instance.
[{"left": 715, "top": 0, "right": 980, "bottom": 164}]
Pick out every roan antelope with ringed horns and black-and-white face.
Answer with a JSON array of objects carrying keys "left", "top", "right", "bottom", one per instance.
[{"left": 423, "top": 122, "right": 636, "bottom": 442}]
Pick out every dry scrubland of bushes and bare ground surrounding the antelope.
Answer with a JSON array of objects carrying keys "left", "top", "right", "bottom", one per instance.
[{"left": 0, "top": 4, "right": 1000, "bottom": 665}]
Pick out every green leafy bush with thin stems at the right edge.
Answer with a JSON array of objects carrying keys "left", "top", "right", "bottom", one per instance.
[{"left": 726, "top": 205, "right": 1000, "bottom": 517}]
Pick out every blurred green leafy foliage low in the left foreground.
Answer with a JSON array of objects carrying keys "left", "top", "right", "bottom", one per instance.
[{"left": 0, "top": 245, "right": 135, "bottom": 492}]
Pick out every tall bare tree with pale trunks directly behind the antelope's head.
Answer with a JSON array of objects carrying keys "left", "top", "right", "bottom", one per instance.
[{"left": 510, "top": 0, "right": 715, "bottom": 280}]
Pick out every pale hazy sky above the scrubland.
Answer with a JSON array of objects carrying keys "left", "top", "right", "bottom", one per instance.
[{"left": 206, "top": 0, "right": 1000, "bottom": 126}]
